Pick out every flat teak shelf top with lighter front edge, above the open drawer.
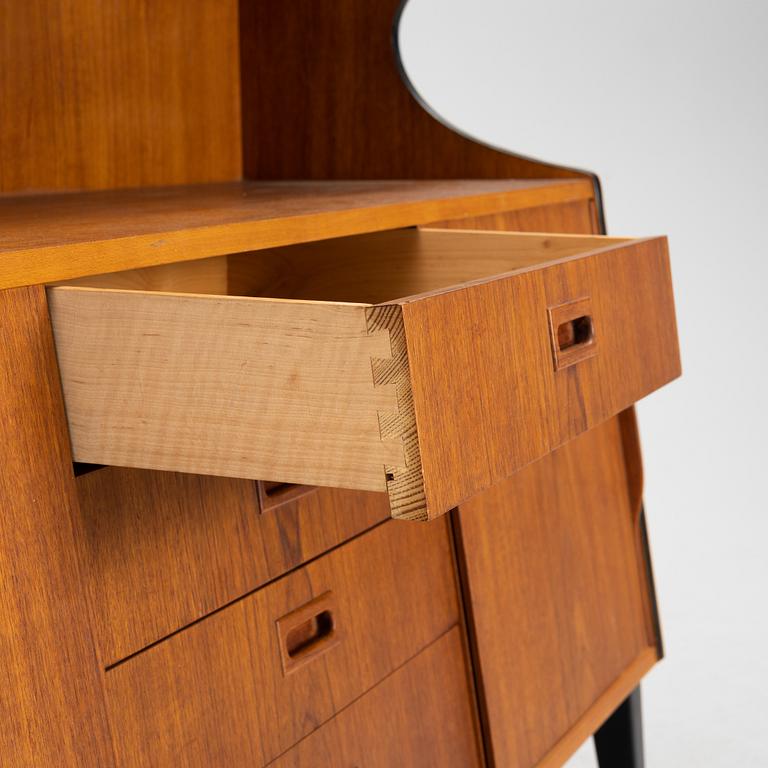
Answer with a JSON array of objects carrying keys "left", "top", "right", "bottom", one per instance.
[{"left": 0, "top": 179, "right": 594, "bottom": 289}]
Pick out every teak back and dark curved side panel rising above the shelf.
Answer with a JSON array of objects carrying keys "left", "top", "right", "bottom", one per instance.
[{"left": 0, "top": 0, "right": 588, "bottom": 192}]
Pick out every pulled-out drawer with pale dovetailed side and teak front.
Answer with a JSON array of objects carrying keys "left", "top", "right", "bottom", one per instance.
[{"left": 48, "top": 229, "right": 680, "bottom": 519}]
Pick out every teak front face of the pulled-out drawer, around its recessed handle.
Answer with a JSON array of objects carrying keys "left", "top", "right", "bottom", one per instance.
[{"left": 402, "top": 232, "right": 680, "bottom": 513}]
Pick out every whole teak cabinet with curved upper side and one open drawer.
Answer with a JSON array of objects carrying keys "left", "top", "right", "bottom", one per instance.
[{"left": 0, "top": 0, "right": 680, "bottom": 768}]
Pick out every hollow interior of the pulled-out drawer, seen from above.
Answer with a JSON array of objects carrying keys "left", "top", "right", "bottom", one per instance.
[{"left": 57, "top": 228, "right": 629, "bottom": 304}]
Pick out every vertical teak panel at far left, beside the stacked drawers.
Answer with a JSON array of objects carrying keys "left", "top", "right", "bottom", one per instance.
[{"left": 0, "top": 288, "right": 114, "bottom": 768}]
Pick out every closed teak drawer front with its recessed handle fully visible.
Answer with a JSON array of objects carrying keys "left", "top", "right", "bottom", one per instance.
[{"left": 106, "top": 521, "right": 458, "bottom": 767}]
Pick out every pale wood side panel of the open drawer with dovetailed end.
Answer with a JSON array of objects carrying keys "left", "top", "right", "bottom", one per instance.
[{"left": 49, "top": 287, "right": 405, "bottom": 490}]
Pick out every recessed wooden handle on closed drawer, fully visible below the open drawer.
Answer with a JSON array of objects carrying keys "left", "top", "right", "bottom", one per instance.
[{"left": 277, "top": 592, "right": 340, "bottom": 675}]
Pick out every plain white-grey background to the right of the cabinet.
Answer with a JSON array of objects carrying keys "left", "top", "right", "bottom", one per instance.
[{"left": 400, "top": 0, "right": 768, "bottom": 768}]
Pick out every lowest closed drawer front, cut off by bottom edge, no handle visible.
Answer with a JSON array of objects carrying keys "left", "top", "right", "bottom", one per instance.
[{"left": 270, "top": 628, "right": 483, "bottom": 768}]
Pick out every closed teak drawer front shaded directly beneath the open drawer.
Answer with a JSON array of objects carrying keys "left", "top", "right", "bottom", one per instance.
[{"left": 77, "top": 467, "right": 389, "bottom": 666}]
